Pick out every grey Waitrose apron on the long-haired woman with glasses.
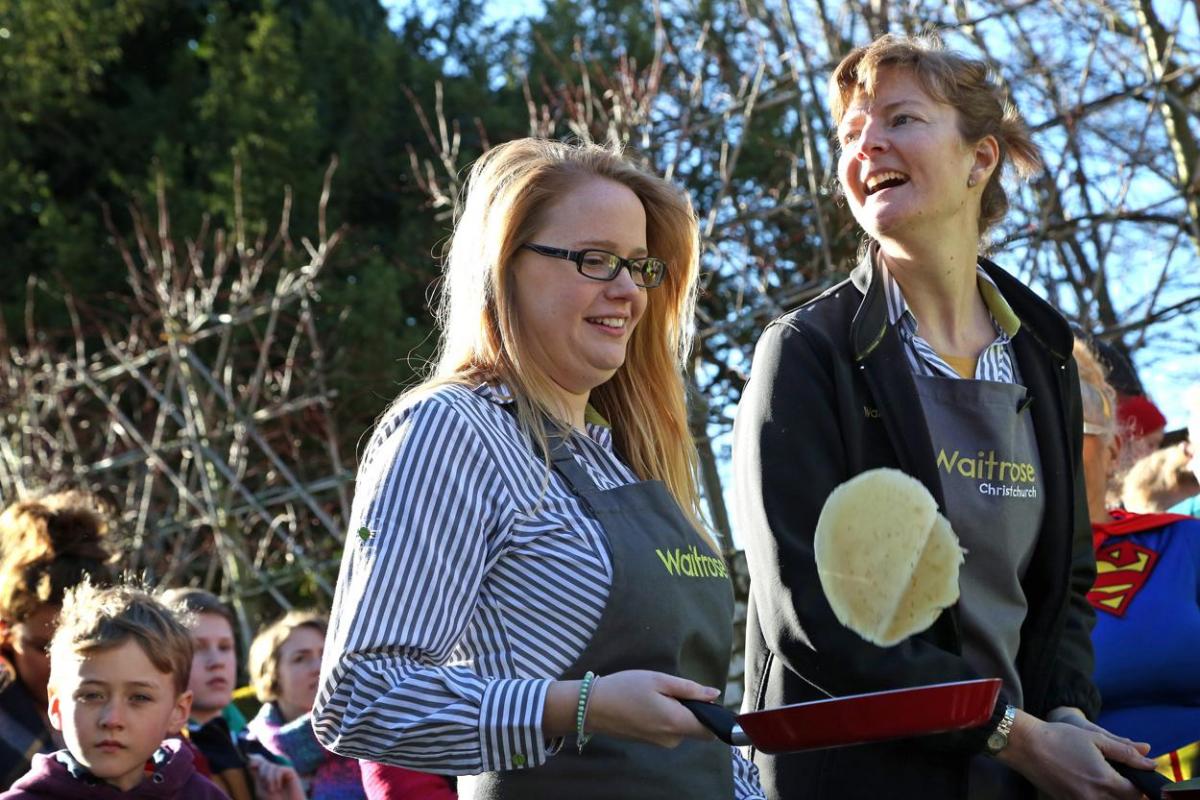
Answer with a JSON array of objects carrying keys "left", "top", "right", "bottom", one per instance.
[{"left": 474, "top": 431, "right": 733, "bottom": 800}]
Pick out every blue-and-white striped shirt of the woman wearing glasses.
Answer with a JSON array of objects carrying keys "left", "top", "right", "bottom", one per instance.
[{"left": 313, "top": 385, "right": 762, "bottom": 799}]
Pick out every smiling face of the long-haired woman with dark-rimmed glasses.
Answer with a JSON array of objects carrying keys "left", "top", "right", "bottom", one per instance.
[{"left": 514, "top": 178, "right": 652, "bottom": 407}]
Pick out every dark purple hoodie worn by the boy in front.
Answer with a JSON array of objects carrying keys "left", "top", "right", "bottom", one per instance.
[{"left": 0, "top": 739, "right": 228, "bottom": 800}]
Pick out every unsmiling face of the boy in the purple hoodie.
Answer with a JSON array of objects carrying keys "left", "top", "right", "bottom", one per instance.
[{"left": 49, "top": 639, "right": 192, "bottom": 792}]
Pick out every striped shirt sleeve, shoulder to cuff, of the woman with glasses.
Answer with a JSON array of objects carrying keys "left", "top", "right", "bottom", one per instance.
[{"left": 313, "top": 397, "right": 551, "bottom": 775}]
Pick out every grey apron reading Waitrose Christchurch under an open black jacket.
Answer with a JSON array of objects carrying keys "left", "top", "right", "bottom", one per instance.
[{"left": 913, "top": 375, "right": 1045, "bottom": 800}]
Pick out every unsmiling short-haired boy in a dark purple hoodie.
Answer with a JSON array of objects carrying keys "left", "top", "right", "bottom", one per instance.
[{"left": 0, "top": 583, "right": 224, "bottom": 800}]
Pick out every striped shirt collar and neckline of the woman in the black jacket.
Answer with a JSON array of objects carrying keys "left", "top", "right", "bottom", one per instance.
[{"left": 880, "top": 264, "right": 1021, "bottom": 384}]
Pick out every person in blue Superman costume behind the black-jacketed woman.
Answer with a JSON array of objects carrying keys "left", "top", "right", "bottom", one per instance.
[{"left": 1075, "top": 341, "right": 1200, "bottom": 781}]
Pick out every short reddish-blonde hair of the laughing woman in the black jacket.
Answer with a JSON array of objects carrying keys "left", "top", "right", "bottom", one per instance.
[{"left": 829, "top": 34, "right": 1042, "bottom": 235}]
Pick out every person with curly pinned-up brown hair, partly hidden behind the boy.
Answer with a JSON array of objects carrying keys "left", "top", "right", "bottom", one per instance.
[{"left": 0, "top": 492, "right": 112, "bottom": 790}]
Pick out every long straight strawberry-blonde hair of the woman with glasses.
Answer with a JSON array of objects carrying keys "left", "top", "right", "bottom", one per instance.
[{"left": 400, "top": 138, "right": 707, "bottom": 546}]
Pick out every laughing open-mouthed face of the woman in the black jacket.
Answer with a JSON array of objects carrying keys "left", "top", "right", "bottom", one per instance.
[{"left": 838, "top": 67, "right": 990, "bottom": 244}]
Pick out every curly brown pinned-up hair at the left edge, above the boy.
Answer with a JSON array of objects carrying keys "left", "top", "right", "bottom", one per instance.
[{"left": 0, "top": 491, "right": 113, "bottom": 624}]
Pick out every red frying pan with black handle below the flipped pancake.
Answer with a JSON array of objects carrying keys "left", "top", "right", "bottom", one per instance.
[{"left": 680, "top": 678, "right": 1001, "bottom": 753}]
